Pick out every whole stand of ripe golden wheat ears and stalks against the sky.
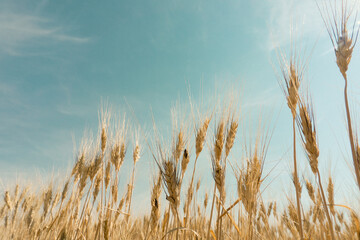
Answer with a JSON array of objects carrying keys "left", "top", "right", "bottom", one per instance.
[{"left": 0, "top": 2, "right": 360, "bottom": 240}]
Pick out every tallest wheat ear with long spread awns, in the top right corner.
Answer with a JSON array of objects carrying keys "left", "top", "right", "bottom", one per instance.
[{"left": 317, "top": 0, "right": 360, "bottom": 78}]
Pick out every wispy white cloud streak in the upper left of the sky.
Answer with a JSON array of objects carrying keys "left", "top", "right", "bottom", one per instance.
[{"left": 0, "top": 12, "right": 90, "bottom": 55}]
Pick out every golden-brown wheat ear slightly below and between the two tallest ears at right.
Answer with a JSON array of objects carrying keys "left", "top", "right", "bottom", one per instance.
[{"left": 296, "top": 97, "right": 319, "bottom": 175}]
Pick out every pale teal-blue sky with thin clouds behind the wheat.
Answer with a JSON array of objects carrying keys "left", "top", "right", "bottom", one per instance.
[{"left": 0, "top": 0, "right": 360, "bottom": 210}]
